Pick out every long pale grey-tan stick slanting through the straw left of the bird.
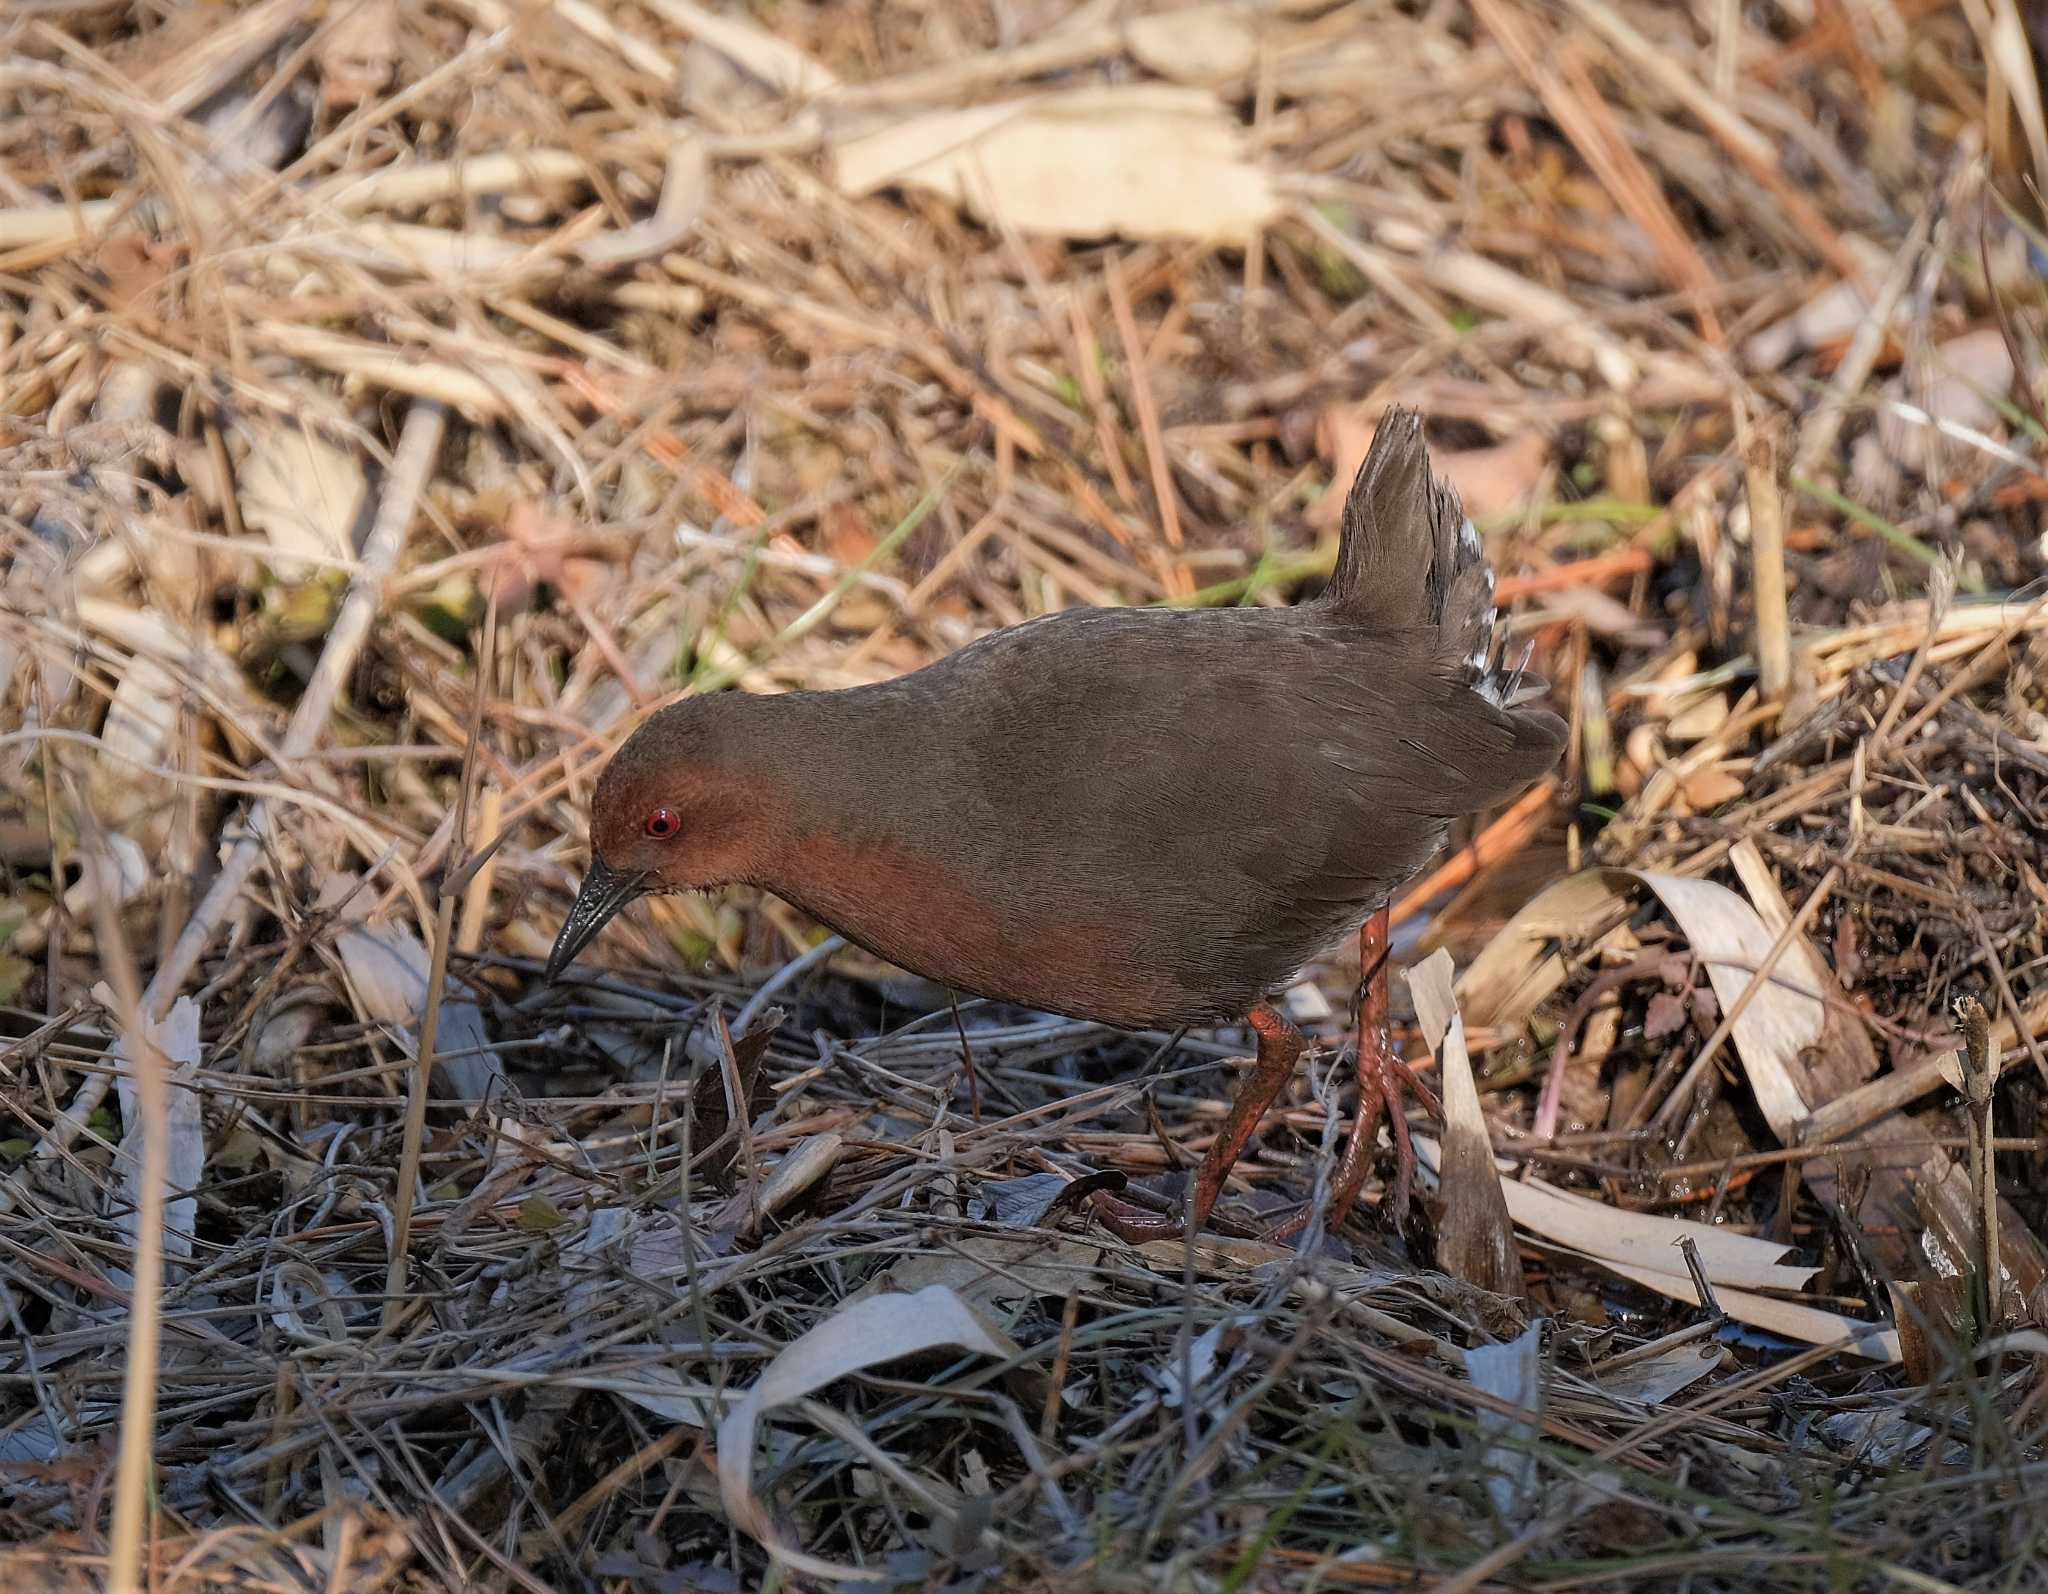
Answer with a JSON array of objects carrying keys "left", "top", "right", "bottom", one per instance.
[{"left": 0, "top": 402, "right": 449, "bottom": 1213}]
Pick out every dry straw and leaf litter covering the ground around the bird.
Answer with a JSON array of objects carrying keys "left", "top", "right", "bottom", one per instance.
[{"left": 0, "top": 0, "right": 2048, "bottom": 1592}]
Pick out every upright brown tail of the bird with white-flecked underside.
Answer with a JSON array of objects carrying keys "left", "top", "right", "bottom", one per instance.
[{"left": 1321, "top": 410, "right": 1544, "bottom": 707}]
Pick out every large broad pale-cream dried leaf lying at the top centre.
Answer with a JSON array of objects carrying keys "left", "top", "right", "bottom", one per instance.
[{"left": 831, "top": 84, "right": 1280, "bottom": 244}]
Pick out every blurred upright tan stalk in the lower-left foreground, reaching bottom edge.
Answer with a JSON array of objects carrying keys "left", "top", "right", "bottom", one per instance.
[{"left": 90, "top": 848, "right": 170, "bottom": 1594}]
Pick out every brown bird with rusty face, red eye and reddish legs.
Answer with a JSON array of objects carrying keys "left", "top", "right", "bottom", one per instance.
[{"left": 547, "top": 408, "right": 1565, "bottom": 1242}]
